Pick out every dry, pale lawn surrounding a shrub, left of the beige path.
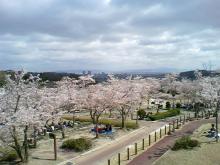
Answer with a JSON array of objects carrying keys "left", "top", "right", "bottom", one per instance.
[{"left": 26, "top": 124, "right": 133, "bottom": 165}]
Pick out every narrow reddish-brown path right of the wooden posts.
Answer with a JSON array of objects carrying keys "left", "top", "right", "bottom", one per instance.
[{"left": 128, "top": 119, "right": 214, "bottom": 165}]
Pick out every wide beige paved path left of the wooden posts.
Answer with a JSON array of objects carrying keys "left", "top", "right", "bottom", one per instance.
[{"left": 57, "top": 121, "right": 167, "bottom": 165}]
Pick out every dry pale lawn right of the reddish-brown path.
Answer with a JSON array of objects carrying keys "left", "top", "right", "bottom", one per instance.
[{"left": 154, "top": 123, "right": 220, "bottom": 165}]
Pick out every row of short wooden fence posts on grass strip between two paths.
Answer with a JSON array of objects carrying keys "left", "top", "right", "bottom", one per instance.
[{"left": 107, "top": 113, "right": 199, "bottom": 165}]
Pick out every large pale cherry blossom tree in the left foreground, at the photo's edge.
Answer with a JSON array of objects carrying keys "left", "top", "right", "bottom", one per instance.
[{"left": 0, "top": 71, "right": 59, "bottom": 162}]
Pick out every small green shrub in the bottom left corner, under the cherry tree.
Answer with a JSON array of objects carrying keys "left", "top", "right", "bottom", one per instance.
[{"left": 0, "top": 147, "right": 17, "bottom": 162}]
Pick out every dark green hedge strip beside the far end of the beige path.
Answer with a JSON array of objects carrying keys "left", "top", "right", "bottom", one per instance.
[{"left": 149, "top": 109, "right": 180, "bottom": 121}]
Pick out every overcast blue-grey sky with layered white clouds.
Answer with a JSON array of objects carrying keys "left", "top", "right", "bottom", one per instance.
[{"left": 0, "top": 0, "right": 220, "bottom": 71}]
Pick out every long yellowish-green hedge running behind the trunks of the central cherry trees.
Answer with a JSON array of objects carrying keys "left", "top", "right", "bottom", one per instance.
[{"left": 62, "top": 115, "right": 138, "bottom": 129}]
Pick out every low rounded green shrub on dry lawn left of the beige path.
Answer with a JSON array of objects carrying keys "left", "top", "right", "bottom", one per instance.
[{"left": 61, "top": 138, "right": 92, "bottom": 152}]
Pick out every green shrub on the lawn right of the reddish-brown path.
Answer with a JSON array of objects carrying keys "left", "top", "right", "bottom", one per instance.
[{"left": 172, "top": 136, "right": 199, "bottom": 151}]
